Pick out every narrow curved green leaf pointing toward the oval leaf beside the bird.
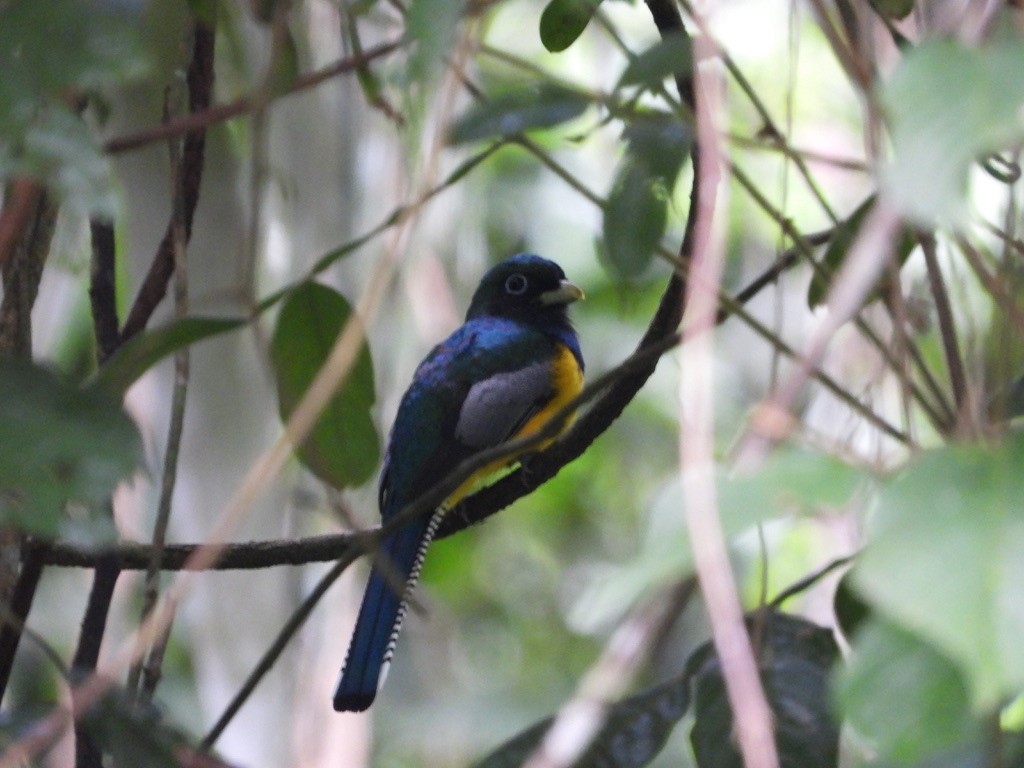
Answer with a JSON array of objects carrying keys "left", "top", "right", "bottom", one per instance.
[{"left": 87, "top": 317, "right": 246, "bottom": 397}]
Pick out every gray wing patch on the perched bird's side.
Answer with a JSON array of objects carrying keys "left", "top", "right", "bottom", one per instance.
[{"left": 455, "top": 361, "right": 554, "bottom": 449}]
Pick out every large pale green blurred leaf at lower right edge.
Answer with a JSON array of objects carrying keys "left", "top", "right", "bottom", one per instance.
[{"left": 852, "top": 433, "right": 1024, "bottom": 710}]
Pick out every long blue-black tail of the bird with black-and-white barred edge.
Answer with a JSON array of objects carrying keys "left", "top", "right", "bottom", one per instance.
[{"left": 334, "top": 512, "right": 441, "bottom": 712}]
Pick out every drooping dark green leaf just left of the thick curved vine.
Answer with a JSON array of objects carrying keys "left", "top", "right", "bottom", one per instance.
[{"left": 602, "top": 114, "right": 691, "bottom": 279}]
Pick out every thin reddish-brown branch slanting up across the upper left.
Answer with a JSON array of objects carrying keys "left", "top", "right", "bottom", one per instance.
[{"left": 103, "top": 40, "right": 404, "bottom": 154}]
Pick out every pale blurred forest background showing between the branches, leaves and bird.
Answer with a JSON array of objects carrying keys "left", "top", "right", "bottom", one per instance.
[{"left": 4, "top": 0, "right": 1019, "bottom": 767}]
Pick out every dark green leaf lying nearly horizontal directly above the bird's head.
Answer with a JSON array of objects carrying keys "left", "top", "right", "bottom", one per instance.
[{"left": 449, "top": 83, "right": 590, "bottom": 144}]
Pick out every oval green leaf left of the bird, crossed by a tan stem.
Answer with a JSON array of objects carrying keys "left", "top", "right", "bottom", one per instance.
[{"left": 270, "top": 282, "right": 380, "bottom": 488}]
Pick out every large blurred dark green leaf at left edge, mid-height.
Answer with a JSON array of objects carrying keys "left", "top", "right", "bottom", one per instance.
[{"left": 0, "top": 358, "right": 143, "bottom": 537}]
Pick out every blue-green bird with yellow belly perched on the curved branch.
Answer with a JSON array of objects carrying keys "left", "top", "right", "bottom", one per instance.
[{"left": 334, "top": 254, "right": 584, "bottom": 712}]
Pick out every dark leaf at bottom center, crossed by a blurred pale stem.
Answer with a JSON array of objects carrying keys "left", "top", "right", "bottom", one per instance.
[{"left": 474, "top": 677, "right": 690, "bottom": 768}]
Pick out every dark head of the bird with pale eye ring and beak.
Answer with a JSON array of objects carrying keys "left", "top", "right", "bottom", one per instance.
[{"left": 466, "top": 253, "right": 583, "bottom": 322}]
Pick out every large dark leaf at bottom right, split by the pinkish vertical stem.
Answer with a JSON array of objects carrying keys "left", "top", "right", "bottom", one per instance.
[{"left": 686, "top": 611, "right": 839, "bottom": 768}]
